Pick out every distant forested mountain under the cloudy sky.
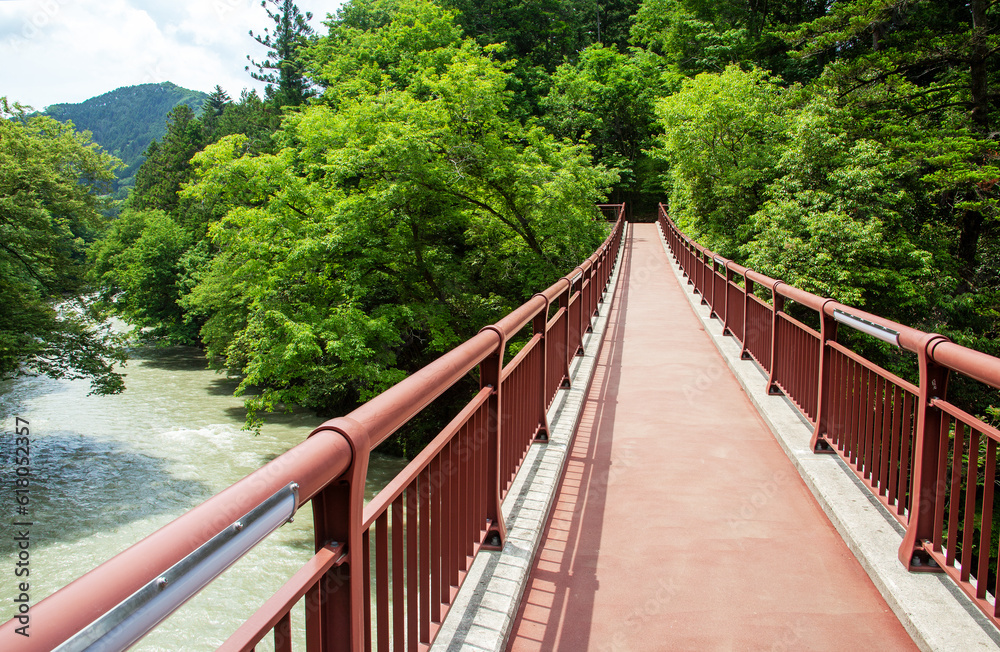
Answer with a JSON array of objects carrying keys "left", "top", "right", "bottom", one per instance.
[{"left": 44, "top": 82, "right": 208, "bottom": 196}]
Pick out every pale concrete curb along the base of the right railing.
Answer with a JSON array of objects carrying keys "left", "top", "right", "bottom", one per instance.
[{"left": 658, "top": 224, "right": 1000, "bottom": 652}]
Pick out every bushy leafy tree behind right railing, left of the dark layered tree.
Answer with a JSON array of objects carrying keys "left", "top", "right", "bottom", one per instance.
[{"left": 740, "top": 95, "right": 940, "bottom": 316}]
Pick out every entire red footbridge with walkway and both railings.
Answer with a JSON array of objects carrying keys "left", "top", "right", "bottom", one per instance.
[{"left": 0, "top": 206, "right": 1000, "bottom": 651}]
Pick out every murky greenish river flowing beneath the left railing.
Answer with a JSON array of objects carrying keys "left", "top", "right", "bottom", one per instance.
[{"left": 0, "top": 347, "right": 404, "bottom": 650}]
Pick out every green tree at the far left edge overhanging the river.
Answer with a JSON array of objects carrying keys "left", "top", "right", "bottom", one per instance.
[{"left": 0, "top": 98, "right": 124, "bottom": 394}]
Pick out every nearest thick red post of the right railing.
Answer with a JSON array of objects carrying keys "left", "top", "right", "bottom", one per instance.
[{"left": 899, "top": 335, "right": 957, "bottom": 573}]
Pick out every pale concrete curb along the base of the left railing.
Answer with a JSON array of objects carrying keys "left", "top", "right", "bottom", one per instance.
[{"left": 430, "top": 225, "right": 630, "bottom": 652}]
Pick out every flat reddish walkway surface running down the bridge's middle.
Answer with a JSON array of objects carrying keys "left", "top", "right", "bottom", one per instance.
[{"left": 508, "top": 224, "right": 916, "bottom": 652}]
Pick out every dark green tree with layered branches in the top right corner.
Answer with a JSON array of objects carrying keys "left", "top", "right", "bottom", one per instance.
[{"left": 788, "top": 0, "right": 1000, "bottom": 282}]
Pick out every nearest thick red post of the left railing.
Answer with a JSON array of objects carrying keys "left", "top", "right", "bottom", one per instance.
[{"left": 306, "top": 417, "right": 371, "bottom": 652}]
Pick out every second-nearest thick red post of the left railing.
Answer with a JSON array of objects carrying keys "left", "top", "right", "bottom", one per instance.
[{"left": 479, "top": 326, "right": 507, "bottom": 550}]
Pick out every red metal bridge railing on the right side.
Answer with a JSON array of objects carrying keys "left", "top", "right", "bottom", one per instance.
[{"left": 659, "top": 205, "right": 1000, "bottom": 625}]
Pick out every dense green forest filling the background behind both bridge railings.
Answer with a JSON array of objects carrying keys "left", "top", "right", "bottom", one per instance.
[{"left": 0, "top": 0, "right": 1000, "bottom": 453}]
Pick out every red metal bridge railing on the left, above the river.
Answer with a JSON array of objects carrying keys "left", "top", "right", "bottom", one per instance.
[{"left": 0, "top": 205, "right": 625, "bottom": 652}]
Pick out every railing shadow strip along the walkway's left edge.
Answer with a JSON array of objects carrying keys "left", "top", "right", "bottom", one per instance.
[{"left": 507, "top": 229, "right": 632, "bottom": 652}]
